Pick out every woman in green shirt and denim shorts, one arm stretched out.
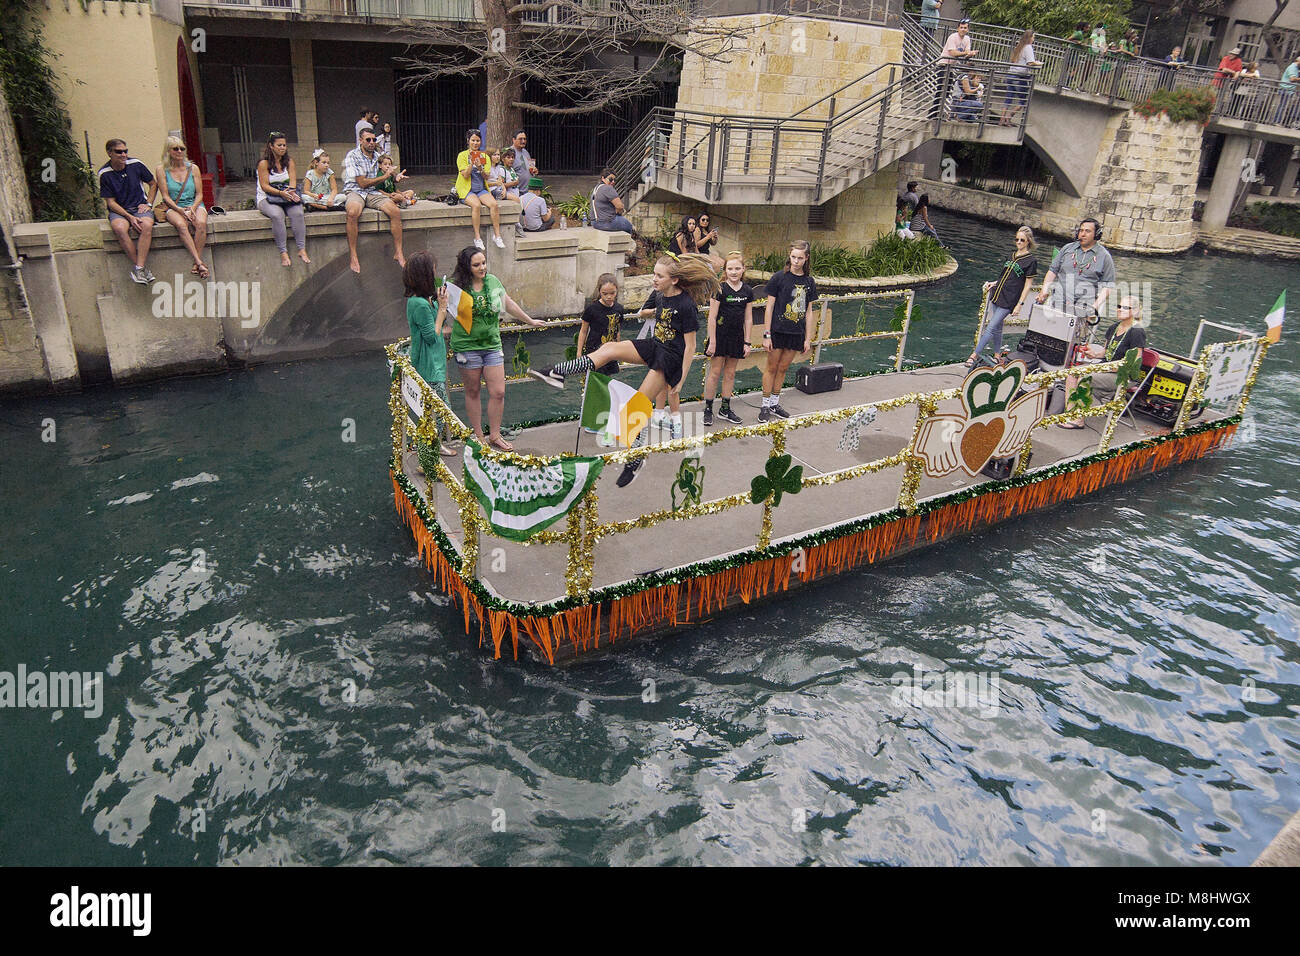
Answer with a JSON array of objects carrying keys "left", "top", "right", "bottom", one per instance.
[{"left": 439, "top": 246, "right": 546, "bottom": 451}]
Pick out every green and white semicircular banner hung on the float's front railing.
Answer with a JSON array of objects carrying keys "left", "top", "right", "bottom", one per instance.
[{"left": 465, "top": 438, "right": 605, "bottom": 541}]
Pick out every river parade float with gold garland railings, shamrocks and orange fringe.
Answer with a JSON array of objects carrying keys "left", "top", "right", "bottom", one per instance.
[{"left": 387, "top": 290, "right": 1282, "bottom": 665}]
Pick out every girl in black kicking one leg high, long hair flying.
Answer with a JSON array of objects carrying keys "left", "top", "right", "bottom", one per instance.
[{"left": 530, "top": 252, "right": 719, "bottom": 488}]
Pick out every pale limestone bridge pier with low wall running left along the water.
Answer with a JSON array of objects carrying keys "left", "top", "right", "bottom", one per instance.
[{"left": 913, "top": 112, "right": 1201, "bottom": 254}]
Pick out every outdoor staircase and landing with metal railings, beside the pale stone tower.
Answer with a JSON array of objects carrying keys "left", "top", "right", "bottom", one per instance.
[{"left": 608, "top": 23, "right": 1032, "bottom": 208}]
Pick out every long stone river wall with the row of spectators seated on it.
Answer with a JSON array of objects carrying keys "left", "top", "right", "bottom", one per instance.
[{"left": 0, "top": 203, "right": 633, "bottom": 392}]
